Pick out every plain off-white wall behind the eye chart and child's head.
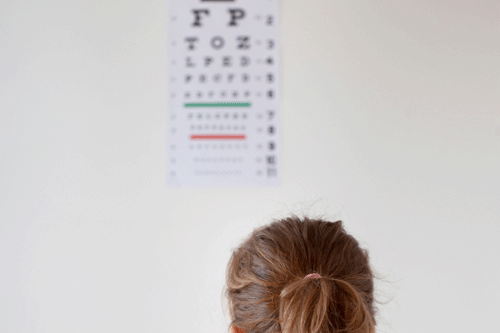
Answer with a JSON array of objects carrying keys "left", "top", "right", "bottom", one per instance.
[{"left": 0, "top": 0, "right": 500, "bottom": 333}]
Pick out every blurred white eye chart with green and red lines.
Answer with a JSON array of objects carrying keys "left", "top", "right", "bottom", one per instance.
[{"left": 167, "top": 0, "right": 280, "bottom": 186}]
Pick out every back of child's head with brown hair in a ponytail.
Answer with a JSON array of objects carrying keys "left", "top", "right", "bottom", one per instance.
[{"left": 226, "top": 217, "right": 375, "bottom": 333}]
